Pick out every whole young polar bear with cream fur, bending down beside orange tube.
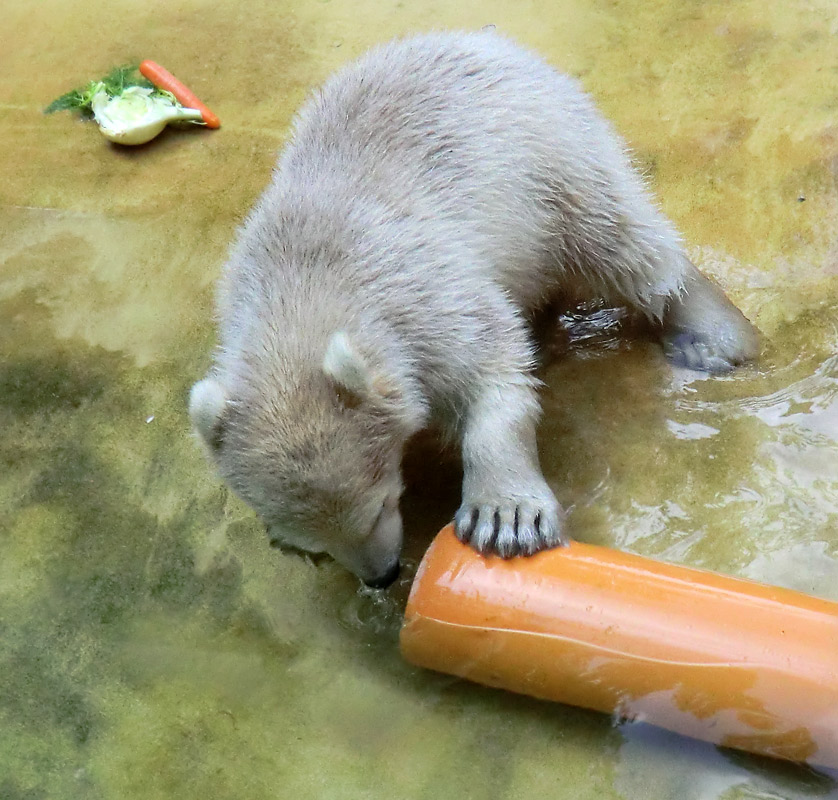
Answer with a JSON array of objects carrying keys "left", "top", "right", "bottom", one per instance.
[{"left": 191, "top": 33, "right": 757, "bottom": 581}]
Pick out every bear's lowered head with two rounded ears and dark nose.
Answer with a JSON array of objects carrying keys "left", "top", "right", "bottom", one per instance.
[{"left": 189, "top": 332, "right": 423, "bottom": 586}]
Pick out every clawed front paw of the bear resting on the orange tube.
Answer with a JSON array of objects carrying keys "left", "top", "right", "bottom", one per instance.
[{"left": 454, "top": 494, "right": 567, "bottom": 558}]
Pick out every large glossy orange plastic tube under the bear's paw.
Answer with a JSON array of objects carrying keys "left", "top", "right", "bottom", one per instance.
[{"left": 401, "top": 528, "right": 838, "bottom": 768}]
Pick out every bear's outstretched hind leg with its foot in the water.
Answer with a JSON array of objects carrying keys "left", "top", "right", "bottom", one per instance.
[{"left": 554, "top": 119, "right": 759, "bottom": 372}]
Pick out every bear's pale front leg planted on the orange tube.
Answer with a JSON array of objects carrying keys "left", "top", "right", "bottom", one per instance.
[{"left": 454, "top": 375, "right": 567, "bottom": 558}]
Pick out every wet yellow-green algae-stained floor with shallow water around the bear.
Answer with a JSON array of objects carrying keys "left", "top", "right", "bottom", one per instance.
[{"left": 0, "top": 0, "right": 838, "bottom": 800}]
